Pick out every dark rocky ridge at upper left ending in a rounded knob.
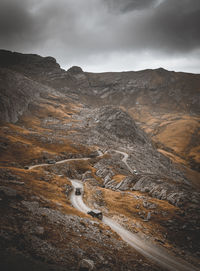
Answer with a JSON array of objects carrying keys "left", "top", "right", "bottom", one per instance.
[{"left": 0, "top": 50, "right": 85, "bottom": 92}]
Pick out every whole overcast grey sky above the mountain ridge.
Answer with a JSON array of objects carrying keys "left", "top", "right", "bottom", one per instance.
[{"left": 0, "top": 0, "right": 200, "bottom": 73}]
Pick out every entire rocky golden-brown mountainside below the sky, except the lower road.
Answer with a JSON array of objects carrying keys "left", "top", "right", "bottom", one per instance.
[{"left": 0, "top": 50, "right": 200, "bottom": 270}]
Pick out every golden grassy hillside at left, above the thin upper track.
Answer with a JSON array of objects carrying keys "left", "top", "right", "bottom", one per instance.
[{"left": 0, "top": 95, "right": 96, "bottom": 166}]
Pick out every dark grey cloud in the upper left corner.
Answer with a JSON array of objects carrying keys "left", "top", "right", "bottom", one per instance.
[{"left": 0, "top": 0, "right": 50, "bottom": 51}]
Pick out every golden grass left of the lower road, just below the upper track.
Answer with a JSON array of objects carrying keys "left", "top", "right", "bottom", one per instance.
[{"left": 0, "top": 167, "right": 84, "bottom": 216}]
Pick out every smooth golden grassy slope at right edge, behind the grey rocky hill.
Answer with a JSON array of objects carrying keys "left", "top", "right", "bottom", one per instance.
[{"left": 129, "top": 106, "right": 200, "bottom": 171}]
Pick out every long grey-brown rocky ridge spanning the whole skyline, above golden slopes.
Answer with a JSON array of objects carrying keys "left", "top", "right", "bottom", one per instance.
[{"left": 0, "top": 50, "right": 200, "bottom": 114}]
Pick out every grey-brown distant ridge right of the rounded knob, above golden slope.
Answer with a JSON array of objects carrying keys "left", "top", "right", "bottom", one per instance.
[{"left": 87, "top": 69, "right": 200, "bottom": 114}]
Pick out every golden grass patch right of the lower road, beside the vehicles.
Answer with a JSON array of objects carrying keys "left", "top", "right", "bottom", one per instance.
[{"left": 84, "top": 183, "right": 182, "bottom": 247}]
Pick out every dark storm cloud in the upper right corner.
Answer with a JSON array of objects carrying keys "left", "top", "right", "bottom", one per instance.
[{"left": 140, "top": 0, "right": 200, "bottom": 52}]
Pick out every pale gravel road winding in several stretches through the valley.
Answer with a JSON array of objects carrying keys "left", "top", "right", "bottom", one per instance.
[{"left": 28, "top": 150, "right": 199, "bottom": 271}]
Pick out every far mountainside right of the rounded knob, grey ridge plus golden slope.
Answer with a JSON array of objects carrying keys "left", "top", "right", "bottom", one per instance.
[{"left": 83, "top": 69, "right": 200, "bottom": 171}]
